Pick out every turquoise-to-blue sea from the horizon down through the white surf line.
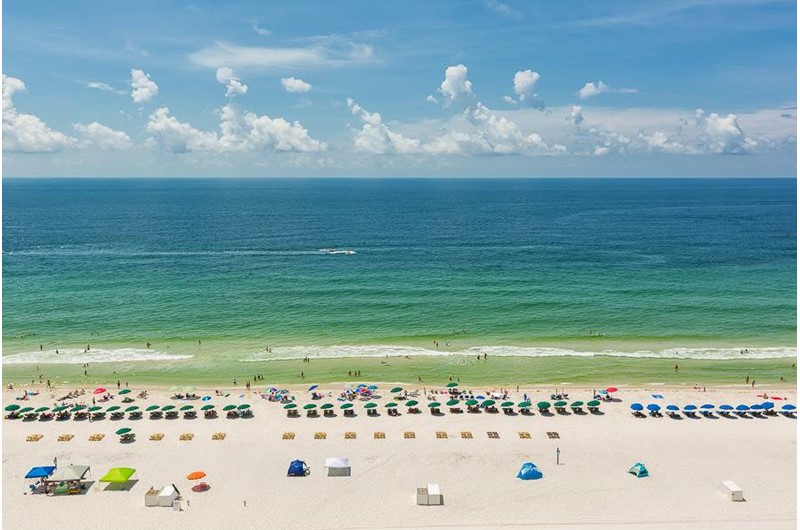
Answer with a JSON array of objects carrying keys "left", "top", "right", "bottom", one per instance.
[{"left": 3, "top": 179, "right": 797, "bottom": 363}]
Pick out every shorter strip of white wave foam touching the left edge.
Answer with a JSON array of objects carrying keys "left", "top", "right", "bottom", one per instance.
[{"left": 3, "top": 348, "right": 193, "bottom": 364}]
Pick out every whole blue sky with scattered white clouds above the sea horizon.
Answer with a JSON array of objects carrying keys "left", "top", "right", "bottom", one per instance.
[{"left": 2, "top": 0, "right": 797, "bottom": 177}]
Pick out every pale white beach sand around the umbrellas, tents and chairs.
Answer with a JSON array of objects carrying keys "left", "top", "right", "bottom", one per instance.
[{"left": 2, "top": 385, "right": 797, "bottom": 530}]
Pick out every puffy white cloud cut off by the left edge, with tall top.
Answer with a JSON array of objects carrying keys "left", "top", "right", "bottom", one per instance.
[{"left": 3, "top": 74, "right": 75, "bottom": 153}]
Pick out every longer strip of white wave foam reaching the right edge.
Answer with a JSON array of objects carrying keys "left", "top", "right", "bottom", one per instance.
[{"left": 239, "top": 344, "right": 797, "bottom": 362}]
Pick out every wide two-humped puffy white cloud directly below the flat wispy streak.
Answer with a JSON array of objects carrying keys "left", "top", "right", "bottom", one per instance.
[{"left": 146, "top": 104, "right": 327, "bottom": 153}]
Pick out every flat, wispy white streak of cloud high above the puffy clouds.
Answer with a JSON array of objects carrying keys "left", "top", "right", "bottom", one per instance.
[{"left": 189, "top": 38, "right": 375, "bottom": 71}]
